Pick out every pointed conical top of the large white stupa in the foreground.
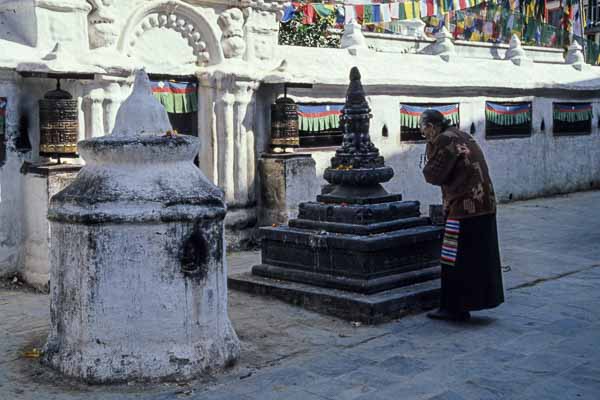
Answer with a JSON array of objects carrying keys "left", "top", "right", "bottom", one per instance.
[{"left": 112, "top": 69, "right": 173, "bottom": 136}]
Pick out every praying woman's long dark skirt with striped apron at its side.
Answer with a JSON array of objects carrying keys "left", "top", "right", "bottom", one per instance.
[{"left": 440, "top": 214, "right": 504, "bottom": 312}]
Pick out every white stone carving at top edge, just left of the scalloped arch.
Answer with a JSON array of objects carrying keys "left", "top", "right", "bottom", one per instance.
[{"left": 88, "top": 0, "right": 119, "bottom": 49}]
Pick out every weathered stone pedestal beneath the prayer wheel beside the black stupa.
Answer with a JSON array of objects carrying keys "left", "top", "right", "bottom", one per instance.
[{"left": 258, "top": 153, "right": 319, "bottom": 225}]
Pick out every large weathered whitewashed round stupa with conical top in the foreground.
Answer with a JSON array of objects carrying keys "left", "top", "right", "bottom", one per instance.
[{"left": 44, "top": 73, "right": 240, "bottom": 382}]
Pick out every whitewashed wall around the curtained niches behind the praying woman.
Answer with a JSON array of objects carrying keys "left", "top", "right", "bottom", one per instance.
[{"left": 282, "top": 87, "right": 600, "bottom": 217}]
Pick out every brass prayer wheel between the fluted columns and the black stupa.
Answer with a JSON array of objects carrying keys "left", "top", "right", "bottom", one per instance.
[{"left": 271, "top": 97, "right": 300, "bottom": 148}]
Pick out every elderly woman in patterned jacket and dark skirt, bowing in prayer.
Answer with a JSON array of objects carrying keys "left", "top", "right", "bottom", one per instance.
[{"left": 420, "top": 110, "right": 504, "bottom": 320}]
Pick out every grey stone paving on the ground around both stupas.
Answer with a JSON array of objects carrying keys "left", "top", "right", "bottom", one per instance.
[{"left": 0, "top": 192, "right": 600, "bottom": 400}]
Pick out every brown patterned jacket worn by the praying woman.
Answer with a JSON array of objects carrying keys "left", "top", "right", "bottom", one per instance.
[{"left": 423, "top": 128, "right": 496, "bottom": 219}]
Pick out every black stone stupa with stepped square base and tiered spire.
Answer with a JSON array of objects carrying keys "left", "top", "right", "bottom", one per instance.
[{"left": 229, "top": 67, "right": 443, "bottom": 323}]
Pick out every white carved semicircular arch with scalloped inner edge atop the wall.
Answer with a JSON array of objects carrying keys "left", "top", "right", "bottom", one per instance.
[{"left": 117, "top": 0, "right": 223, "bottom": 66}]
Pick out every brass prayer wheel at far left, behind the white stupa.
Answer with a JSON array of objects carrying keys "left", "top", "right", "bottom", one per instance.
[{"left": 39, "top": 81, "right": 79, "bottom": 157}]
